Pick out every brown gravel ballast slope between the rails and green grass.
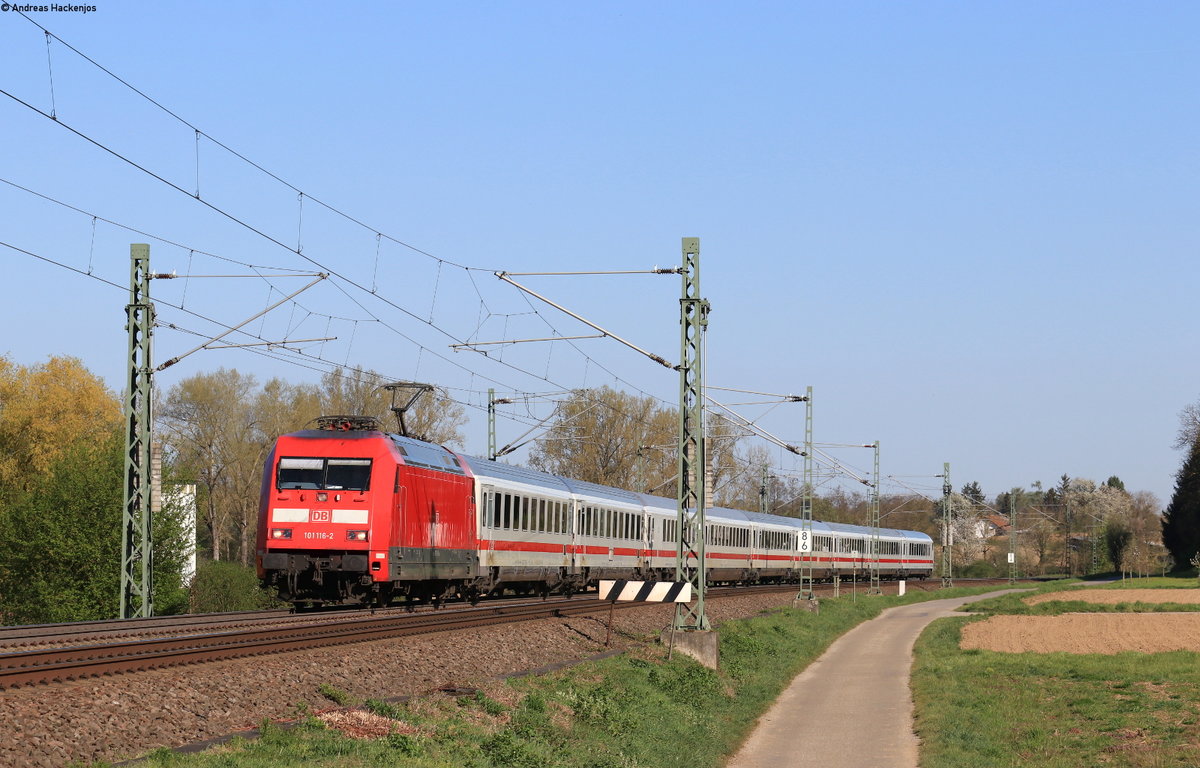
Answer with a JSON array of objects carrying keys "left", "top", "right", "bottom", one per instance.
[{"left": 7, "top": 593, "right": 806, "bottom": 768}]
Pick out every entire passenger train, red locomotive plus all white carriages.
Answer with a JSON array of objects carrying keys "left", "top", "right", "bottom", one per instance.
[{"left": 258, "top": 416, "right": 932, "bottom": 605}]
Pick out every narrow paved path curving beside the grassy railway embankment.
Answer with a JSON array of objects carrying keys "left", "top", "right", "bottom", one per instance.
[{"left": 726, "top": 589, "right": 1014, "bottom": 768}]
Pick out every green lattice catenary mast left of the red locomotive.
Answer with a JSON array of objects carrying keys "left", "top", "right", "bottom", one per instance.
[{"left": 121, "top": 244, "right": 154, "bottom": 619}]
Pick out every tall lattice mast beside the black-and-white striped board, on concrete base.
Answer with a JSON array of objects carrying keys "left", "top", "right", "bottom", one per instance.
[{"left": 672, "top": 238, "right": 710, "bottom": 631}]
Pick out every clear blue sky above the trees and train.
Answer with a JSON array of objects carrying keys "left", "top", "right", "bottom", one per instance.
[{"left": 0, "top": 0, "right": 1200, "bottom": 503}]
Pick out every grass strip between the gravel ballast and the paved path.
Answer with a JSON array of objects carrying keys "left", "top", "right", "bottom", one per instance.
[{"left": 126, "top": 588, "right": 994, "bottom": 768}]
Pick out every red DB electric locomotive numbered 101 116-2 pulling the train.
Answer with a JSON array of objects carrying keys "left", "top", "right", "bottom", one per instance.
[{"left": 257, "top": 416, "right": 478, "bottom": 605}]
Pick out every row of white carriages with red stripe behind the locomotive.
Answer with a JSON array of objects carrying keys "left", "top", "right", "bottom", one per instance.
[{"left": 453, "top": 456, "right": 932, "bottom": 593}]
